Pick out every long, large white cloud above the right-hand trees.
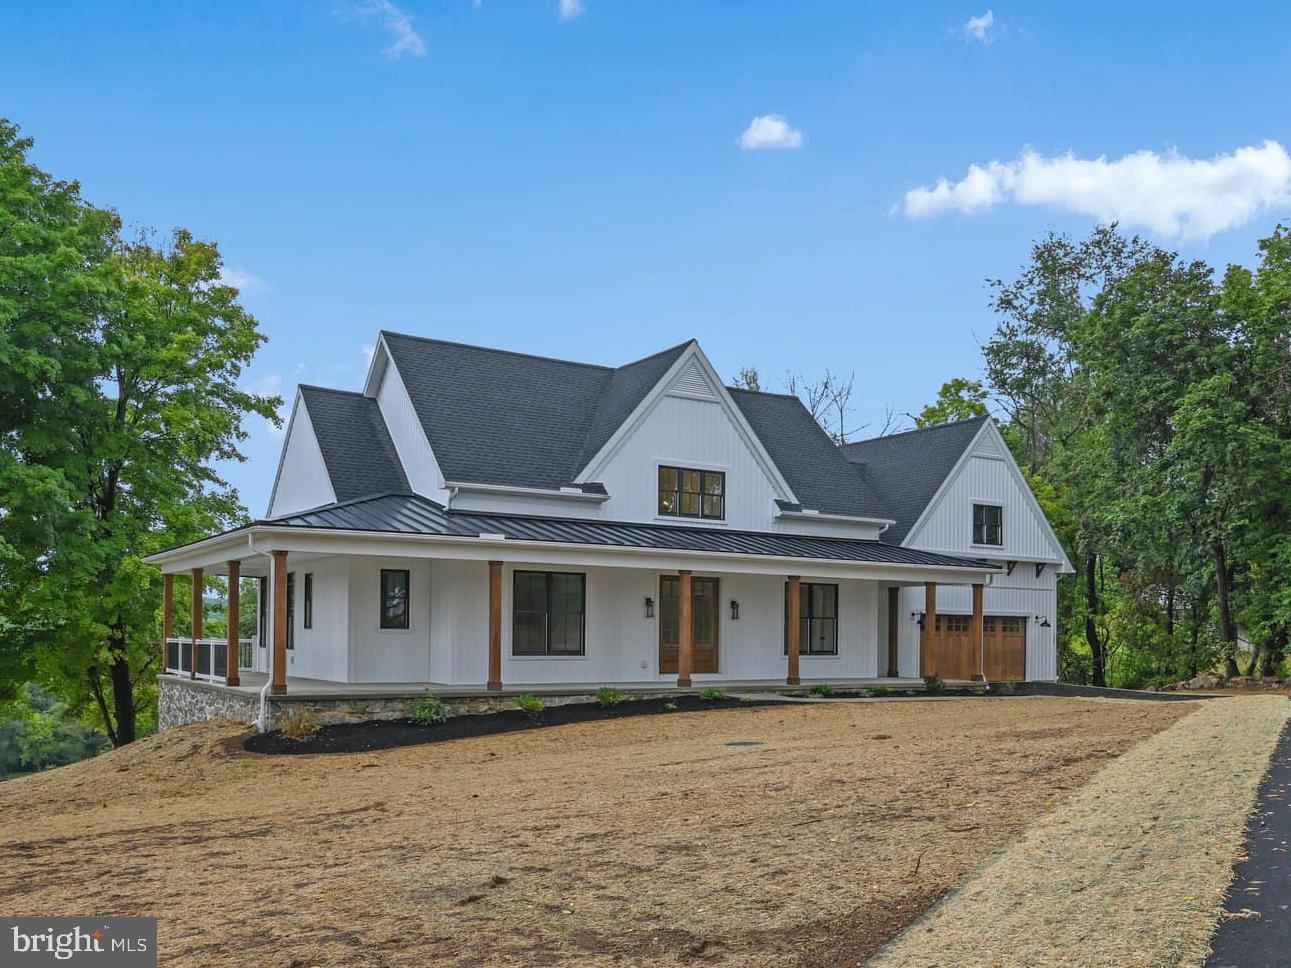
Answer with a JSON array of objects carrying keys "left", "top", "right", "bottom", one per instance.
[{"left": 899, "top": 141, "right": 1291, "bottom": 239}]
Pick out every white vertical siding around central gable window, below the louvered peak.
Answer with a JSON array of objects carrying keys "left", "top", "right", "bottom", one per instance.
[{"left": 598, "top": 396, "right": 776, "bottom": 530}]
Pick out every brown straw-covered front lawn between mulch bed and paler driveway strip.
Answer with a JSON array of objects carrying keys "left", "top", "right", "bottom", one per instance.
[{"left": 0, "top": 698, "right": 1187, "bottom": 967}]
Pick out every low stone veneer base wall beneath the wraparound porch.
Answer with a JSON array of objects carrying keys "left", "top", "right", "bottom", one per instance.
[{"left": 158, "top": 675, "right": 673, "bottom": 729}]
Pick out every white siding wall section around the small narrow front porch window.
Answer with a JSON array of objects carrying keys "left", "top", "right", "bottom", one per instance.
[{"left": 345, "top": 558, "right": 434, "bottom": 683}]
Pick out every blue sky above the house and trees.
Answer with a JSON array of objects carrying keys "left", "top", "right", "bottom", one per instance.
[{"left": 0, "top": 0, "right": 1291, "bottom": 514}]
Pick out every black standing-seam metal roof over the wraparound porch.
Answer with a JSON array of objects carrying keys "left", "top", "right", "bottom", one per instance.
[{"left": 262, "top": 494, "right": 995, "bottom": 569}]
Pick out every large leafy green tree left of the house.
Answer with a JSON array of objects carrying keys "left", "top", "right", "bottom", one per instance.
[{"left": 0, "top": 126, "right": 280, "bottom": 745}]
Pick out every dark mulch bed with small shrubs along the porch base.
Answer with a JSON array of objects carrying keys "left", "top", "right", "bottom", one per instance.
[{"left": 244, "top": 696, "right": 777, "bottom": 755}]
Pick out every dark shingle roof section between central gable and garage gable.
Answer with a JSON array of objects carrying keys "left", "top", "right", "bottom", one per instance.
[{"left": 727, "top": 387, "right": 892, "bottom": 518}]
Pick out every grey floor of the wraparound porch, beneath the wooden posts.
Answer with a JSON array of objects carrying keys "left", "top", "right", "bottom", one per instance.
[{"left": 203, "top": 670, "right": 950, "bottom": 700}]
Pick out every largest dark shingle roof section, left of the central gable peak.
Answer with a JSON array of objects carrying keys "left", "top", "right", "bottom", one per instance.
[{"left": 382, "top": 332, "right": 688, "bottom": 488}]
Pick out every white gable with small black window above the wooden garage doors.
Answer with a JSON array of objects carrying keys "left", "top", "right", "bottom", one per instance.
[{"left": 902, "top": 419, "right": 1072, "bottom": 573}]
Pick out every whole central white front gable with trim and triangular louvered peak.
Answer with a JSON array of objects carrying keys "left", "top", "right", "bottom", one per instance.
[{"left": 576, "top": 342, "right": 797, "bottom": 530}]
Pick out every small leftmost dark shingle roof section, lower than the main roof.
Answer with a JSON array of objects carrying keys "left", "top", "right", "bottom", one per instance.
[{"left": 301, "top": 386, "right": 408, "bottom": 501}]
